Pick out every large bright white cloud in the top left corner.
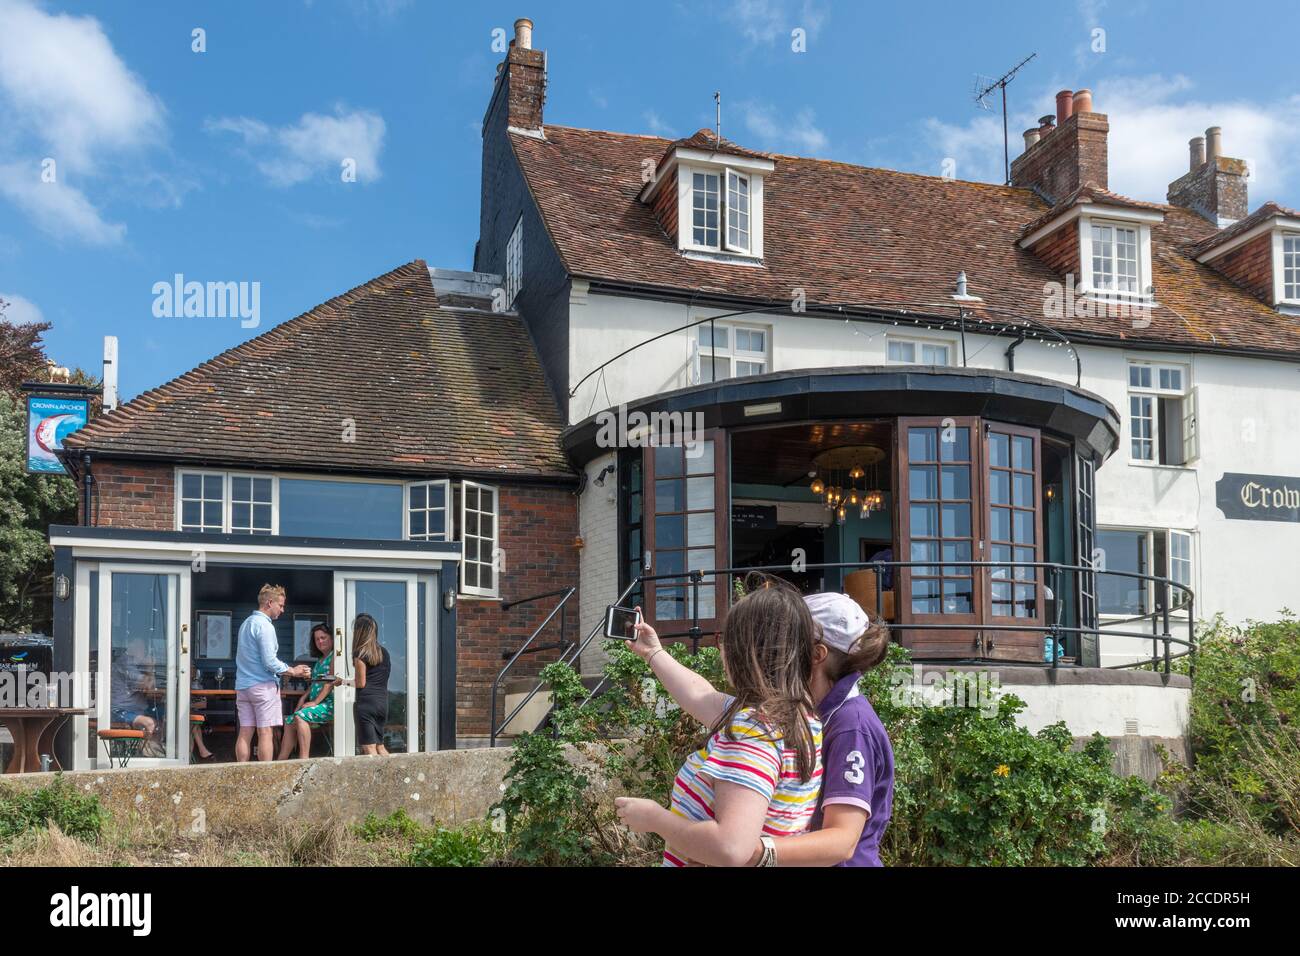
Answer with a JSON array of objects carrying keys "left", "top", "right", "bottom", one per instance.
[{"left": 0, "top": 0, "right": 163, "bottom": 170}]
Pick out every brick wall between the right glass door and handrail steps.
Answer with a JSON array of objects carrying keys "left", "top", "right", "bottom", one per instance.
[{"left": 456, "top": 485, "right": 579, "bottom": 737}]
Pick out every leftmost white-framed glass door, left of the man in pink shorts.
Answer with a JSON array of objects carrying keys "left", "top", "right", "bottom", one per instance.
[{"left": 95, "top": 564, "right": 190, "bottom": 767}]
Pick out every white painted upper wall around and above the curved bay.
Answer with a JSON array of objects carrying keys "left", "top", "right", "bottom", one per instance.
[{"left": 569, "top": 294, "right": 1300, "bottom": 650}]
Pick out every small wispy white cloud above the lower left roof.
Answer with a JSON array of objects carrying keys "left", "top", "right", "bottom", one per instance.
[{"left": 204, "top": 104, "right": 386, "bottom": 186}]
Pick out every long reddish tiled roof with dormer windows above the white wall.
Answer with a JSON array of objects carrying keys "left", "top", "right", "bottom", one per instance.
[{"left": 511, "top": 126, "right": 1300, "bottom": 352}]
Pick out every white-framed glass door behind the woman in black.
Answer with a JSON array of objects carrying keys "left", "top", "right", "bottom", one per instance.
[{"left": 334, "top": 572, "right": 428, "bottom": 757}]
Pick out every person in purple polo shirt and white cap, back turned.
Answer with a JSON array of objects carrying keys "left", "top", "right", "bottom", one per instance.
[{"left": 750, "top": 593, "right": 893, "bottom": 866}]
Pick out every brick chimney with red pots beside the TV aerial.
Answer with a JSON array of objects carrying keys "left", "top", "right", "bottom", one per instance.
[{"left": 1011, "top": 90, "right": 1110, "bottom": 203}]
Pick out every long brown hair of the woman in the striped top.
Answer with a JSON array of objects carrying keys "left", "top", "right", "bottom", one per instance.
[{"left": 711, "top": 574, "right": 816, "bottom": 783}]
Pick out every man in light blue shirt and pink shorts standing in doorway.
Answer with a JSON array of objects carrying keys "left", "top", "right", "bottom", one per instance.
[{"left": 235, "top": 584, "right": 311, "bottom": 763}]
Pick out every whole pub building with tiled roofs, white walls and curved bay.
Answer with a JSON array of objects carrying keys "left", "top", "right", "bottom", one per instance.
[{"left": 51, "top": 20, "right": 1300, "bottom": 771}]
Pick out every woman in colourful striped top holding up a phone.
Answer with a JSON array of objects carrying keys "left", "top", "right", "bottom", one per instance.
[{"left": 615, "top": 580, "right": 822, "bottom": 866}]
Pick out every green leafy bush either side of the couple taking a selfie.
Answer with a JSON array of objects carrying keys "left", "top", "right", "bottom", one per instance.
[{"left": 498, "top": 641, "right": 1175, "bottom": 866}]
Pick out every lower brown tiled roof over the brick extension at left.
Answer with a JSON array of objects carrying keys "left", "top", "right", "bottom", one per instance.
[{"left": 65, "top": 260, "right": 572, "bottom": 477}]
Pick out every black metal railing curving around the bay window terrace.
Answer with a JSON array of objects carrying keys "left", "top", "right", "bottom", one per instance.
[{"left": 493, "top": 561, "right": 1196, "bottom": 747}]
